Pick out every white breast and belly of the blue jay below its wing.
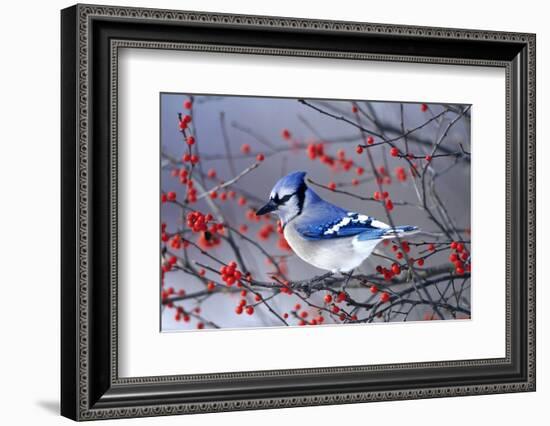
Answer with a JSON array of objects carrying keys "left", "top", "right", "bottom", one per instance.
[{"left": 284, "top": 221, "right": 380, "bottom": 272}]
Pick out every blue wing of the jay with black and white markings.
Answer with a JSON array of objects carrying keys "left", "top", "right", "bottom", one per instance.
[{"left": 296, "top": 208, "right": 391, "bottom": 240}]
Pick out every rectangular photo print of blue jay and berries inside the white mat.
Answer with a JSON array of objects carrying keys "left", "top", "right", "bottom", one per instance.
[{"left": 159, "top": 93, "right": 472, "bottom": 332}]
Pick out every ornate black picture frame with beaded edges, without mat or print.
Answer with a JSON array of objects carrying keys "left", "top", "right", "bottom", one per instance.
[{"left": 61, "top": 5, "right": 535, "bottom": 420}]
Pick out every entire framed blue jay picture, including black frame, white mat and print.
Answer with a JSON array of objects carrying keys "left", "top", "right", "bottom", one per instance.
[{"left": 61, "top": 5, "right": 535, "bottom": 420}]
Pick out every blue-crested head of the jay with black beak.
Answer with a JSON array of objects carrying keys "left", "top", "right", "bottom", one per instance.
[{"left": 256, "top": 172, "right": 308, "bottom": 224}]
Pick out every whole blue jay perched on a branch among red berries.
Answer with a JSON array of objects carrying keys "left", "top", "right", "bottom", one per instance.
[{"left": 256, "top": 172, "right": 418, "bottom": 276}]
